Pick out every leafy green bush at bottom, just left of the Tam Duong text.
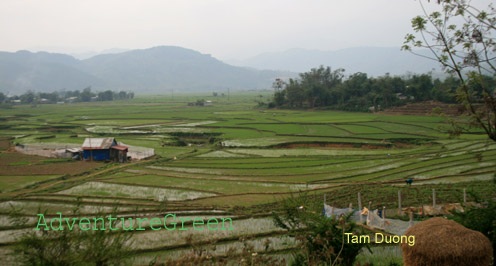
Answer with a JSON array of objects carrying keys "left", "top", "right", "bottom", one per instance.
[{"left": 274, "top": 194, "right": 366, "bottom": 265}]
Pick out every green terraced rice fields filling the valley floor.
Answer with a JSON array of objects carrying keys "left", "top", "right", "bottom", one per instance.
[{"left": 0, "top": 94, "right": 496, "bottom": 264}]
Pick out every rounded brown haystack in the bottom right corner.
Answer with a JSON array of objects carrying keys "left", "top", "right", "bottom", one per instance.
[{"left": 400, "top": 218, "right": 493, "bottom": 266}]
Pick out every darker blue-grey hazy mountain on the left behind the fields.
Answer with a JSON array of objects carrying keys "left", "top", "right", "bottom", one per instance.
[{"left": 0, "top": 46, "right": 294, "bottom": 94}]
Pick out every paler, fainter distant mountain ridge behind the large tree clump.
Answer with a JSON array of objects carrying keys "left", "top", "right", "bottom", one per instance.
[{"left": 226, "top": 47, "right": 441, "bottom": 76}]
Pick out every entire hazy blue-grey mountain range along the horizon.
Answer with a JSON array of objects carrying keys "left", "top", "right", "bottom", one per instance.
[{"left": 0, "top": 46, "right": 438, "bottom": 94}]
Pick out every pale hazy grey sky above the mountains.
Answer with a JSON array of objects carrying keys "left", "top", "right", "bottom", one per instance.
[{"left": 0, "top": 0, "right": 489, "bottom": 59}]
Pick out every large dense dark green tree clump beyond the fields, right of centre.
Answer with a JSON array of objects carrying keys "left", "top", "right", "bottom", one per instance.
[{"left": 268, "top": 66, "right": 496, "bottom": 111}]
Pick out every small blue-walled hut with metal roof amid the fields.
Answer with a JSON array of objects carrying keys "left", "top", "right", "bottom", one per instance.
[{"left": 82, "top": 138, "right": 128, "bottom": 162}]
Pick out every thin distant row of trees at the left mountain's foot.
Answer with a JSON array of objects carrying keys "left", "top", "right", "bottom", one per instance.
[{"left": 0, "top": 87, "right": 134, "bottom": 104}]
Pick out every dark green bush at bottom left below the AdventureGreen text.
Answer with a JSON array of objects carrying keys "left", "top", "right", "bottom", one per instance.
[{"left": 10, "top": 206, "right": 131, "bottom": 266}]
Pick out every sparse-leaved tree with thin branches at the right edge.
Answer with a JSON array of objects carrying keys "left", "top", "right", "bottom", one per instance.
[{"left": 402, "top": 0, "right": 496, "bottom": 141}]
